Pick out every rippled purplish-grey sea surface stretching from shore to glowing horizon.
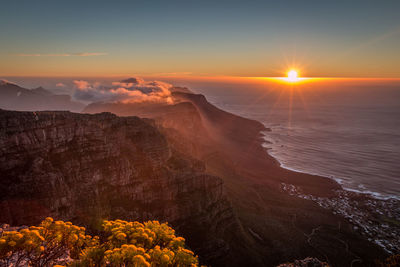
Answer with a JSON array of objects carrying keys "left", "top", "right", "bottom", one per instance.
[{"left": 186, "top": 78, "right": 400, "bottom": 199}]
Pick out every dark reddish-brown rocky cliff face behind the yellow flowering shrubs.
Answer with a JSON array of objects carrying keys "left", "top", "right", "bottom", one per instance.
[{"left": 0, "top": 110, "right": 240, "bottom": 262}]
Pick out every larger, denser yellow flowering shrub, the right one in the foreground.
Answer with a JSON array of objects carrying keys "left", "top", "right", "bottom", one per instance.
[{"left": 75, "top": 220, "right": 198, "bottom": 267}]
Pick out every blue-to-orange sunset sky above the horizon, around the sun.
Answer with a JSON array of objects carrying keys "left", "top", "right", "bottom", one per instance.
[{"left": 0, "top": 0, "right": 400, "bottom": 78}]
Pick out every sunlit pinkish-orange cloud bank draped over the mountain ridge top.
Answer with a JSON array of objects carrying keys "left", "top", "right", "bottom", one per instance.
[{"left": 74, "top": 78, "right": 173, "bottom": 103}]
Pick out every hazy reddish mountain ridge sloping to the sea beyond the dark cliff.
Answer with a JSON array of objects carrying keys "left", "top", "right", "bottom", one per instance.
[{"left": 84, "top": 92, "right": 387, "bottom": 266}]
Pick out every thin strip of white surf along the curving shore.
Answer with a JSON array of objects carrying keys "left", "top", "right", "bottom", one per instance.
[{"left": 260, "top": 131, "right": 400, "bottom": 201}]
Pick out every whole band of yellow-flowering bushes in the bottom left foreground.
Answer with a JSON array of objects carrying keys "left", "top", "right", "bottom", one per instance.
[{"left": 0, "top": 218, "right": 198, "bottom": 267}]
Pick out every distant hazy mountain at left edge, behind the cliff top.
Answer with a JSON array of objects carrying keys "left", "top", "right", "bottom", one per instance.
[{"left": 0, "top": 80, "right": 84, "bottom": 112}]
